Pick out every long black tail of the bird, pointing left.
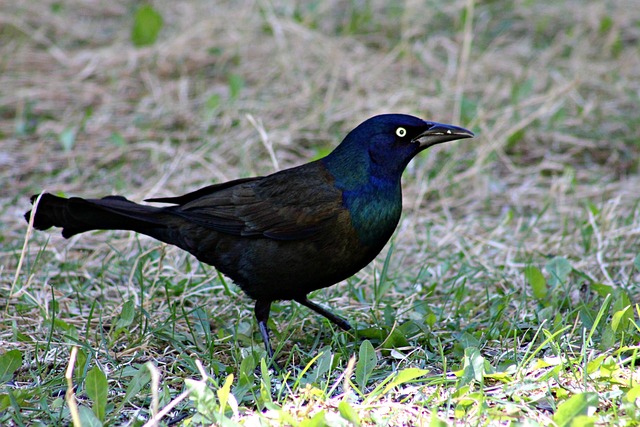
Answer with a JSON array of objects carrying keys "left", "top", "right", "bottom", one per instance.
[{"left": 24, "top": 193, "right": 166, "bottom": 240}]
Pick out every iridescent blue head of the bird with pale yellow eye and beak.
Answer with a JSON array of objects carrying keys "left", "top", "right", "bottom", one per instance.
[{"left": 324, "top": 114, "right": 473, "bottom": 187}]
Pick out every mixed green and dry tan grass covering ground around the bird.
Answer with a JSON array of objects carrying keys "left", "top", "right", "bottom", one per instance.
[{"left": 0, "top": 0, "right": 640, "bottom": 426}]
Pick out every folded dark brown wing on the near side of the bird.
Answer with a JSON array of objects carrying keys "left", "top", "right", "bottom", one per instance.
[{"left": 158, "top": 163, "right": 344, "bottom": 240}]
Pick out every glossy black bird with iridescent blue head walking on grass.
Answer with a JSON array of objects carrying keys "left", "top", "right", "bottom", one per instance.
[{"left": 24, "top": 114, "right": 474, "bottom": 360}]
